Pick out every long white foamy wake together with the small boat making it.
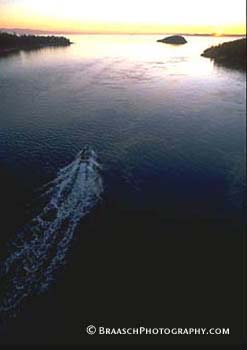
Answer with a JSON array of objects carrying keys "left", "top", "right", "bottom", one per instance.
[{"left": 0, "top": 147, "right": 103, "bottom": 313}]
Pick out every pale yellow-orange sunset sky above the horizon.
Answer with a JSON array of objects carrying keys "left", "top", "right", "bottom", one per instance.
[{"left": 0, "top": 0, "right": 246, "bottom": 34}]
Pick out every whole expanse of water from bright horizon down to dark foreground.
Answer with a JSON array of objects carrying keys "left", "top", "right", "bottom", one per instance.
[{"left": 0, "top": 35, "right": 245, "bottom": 344}]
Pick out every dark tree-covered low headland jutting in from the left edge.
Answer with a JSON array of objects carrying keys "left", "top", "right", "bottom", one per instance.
[{"left": 0, "top": 32, "right": 72, "bottom": 55}]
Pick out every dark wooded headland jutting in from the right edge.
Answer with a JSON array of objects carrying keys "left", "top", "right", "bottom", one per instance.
[{"left": 202, "top": 38, "right": 246, "bottom": 70}]
